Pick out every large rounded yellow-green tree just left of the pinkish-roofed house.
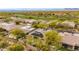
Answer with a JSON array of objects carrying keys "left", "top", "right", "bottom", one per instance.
[{"left": 45, "top": 30, "right": 61, "bottom": 49}]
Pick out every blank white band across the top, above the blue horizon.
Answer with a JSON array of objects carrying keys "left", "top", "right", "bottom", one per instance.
[{"left": 0, "top": 0, "right": 79, "bottom": 9}]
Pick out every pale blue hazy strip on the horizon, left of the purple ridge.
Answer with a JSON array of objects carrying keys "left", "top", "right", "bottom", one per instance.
[{"left": 0, "top": 8, "right": 63, "bottom": 12}]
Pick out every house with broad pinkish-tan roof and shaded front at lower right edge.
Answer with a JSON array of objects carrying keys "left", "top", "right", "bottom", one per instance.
[{"left": 59, "top": 32, "right": 79, "bottom": 50}]
